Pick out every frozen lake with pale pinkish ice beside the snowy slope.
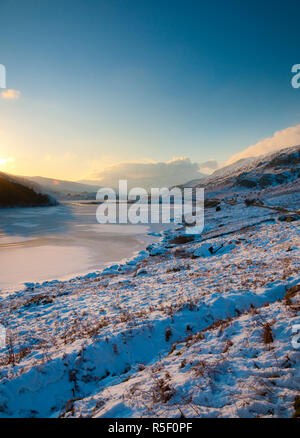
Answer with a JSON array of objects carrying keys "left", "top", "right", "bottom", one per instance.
[{"left": 0, "top": 202, "right": 165, "bottom": 293}]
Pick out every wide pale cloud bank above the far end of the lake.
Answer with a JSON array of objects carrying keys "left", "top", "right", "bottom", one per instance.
[{"left": 89, "top": 157, "right": 214, "bottom": 189}]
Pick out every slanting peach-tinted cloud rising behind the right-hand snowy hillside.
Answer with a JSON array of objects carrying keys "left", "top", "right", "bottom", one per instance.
[{"left": 225, "top": 124, "right": 300, "bottom": 166}]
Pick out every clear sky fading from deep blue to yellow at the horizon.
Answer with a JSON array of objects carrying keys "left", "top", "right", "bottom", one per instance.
[{"left": 0, "top": 0, "right": 300, "bottom": 180}]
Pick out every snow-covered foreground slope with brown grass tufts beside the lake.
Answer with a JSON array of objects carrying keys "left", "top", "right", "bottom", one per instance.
[{"left": 0, "top": 158, "right": 300, "bottom": 418}]
